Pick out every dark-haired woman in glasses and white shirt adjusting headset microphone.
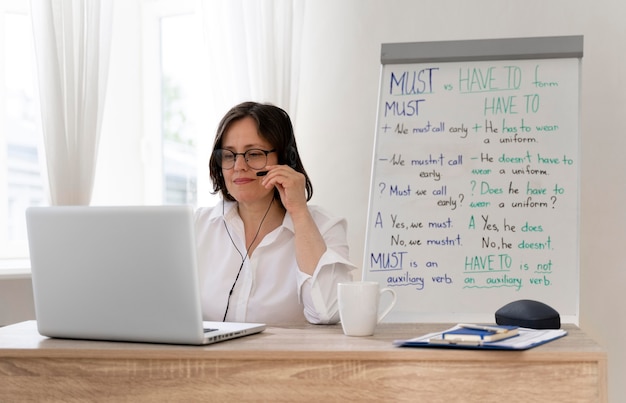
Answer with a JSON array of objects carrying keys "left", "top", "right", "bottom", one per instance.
[{"left": 196, "top": 102, "right": 354, "bottom": 324}]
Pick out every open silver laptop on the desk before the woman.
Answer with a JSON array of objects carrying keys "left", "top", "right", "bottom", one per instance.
[{"left": 26, "top": 206, "right": 265, "bottom": 345}]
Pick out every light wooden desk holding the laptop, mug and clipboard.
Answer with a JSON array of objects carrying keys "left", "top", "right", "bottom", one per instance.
[{"left": 0, "top": 321, "right": 607, "bottom": 403}]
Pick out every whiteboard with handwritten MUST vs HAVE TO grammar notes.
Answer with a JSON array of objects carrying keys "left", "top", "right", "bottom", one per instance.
[{"left": 362, "top": 37, "right": 582, "bottom": 323}]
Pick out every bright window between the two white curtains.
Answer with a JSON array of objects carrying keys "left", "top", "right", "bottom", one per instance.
[{"left": 142, "top": 0, "right": 216, "bottom": 211}]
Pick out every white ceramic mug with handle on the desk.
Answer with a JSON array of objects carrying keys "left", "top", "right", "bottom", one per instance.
[{"left": 337, "top": 281, "right": 397, "bottom": 336}]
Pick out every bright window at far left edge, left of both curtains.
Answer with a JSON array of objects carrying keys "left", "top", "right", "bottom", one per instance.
[{"left": 0, "top": 9, "right": 47, "bottom": 258}]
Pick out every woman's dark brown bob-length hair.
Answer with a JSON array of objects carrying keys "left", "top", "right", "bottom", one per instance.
[{"left": 209, "top": 102, "right": 313, "bottom": 201}]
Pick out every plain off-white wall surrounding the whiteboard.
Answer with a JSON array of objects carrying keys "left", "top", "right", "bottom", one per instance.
[{"left": 295, "top": 0, "right": 626, "bottom": 401}]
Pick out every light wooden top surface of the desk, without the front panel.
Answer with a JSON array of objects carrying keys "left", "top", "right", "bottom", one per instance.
[{"left": 0, "top": 321, "right": 605, "bottom": 361}]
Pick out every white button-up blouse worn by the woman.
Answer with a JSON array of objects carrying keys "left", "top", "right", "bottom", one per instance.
[{"left": 195, "top": 202, "right": 355, "bottom": 324}]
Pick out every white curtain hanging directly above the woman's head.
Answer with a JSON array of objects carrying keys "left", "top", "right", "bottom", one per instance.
[{"left": 201, "top": 0, "right": 304, "bottom": 118}]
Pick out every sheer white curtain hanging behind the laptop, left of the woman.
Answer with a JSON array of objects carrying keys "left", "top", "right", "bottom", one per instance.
[{"left": 31, "top": 0, "right": 113, "bottom": 205}]
